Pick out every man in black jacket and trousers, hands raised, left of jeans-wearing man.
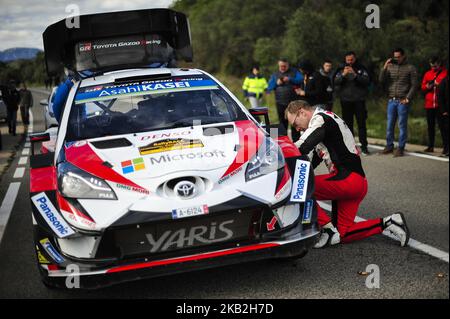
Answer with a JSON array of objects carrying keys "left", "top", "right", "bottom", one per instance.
[{"left": 334, "top": 52, "right": 370, "bottom": 155}]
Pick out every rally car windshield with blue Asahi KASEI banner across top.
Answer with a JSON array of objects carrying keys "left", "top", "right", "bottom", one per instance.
[{"left": 66, "top": 76, "right": 248, "bottom": 141}]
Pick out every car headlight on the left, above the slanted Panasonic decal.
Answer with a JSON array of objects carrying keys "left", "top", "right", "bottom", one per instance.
[{"left": 58, "top": 162, "right": 117, "bottom": 199}]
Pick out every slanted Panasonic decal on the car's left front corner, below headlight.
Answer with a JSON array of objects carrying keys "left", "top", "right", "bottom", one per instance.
[{"left": 31, "top": 192, "right": 75, "bottom": 238}]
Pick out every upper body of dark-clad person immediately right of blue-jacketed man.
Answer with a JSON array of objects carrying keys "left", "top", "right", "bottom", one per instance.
[{"left": 295, "top": 61, "right": 330, "bottom": 107}]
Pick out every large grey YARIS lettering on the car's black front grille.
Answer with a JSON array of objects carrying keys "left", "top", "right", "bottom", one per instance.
[{"left": 145, "top": 219, "right": 234, "bottom": 253}]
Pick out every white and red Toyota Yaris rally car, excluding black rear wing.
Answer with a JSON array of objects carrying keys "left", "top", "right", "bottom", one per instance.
[{"left": 30, "top": 10, "right": 319, "bottom": 288}]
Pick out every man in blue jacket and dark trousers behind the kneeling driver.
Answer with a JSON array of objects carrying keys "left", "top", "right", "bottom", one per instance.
[{"left": 267, "top": 58, "right": 303, "bottom": 142}]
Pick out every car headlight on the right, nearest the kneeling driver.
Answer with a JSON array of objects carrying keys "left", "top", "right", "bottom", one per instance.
[{"left": 245, "top": 138, "right": 285, "bottom": 182}]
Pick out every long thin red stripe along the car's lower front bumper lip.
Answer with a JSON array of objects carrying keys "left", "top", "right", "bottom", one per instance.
[{"left": 106, "top": 243, "right": 280, "bottom": 273}]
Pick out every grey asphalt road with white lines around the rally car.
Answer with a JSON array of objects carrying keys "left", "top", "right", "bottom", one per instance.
[{"left": 0, "top": 90, "right": 449, "bottom": 299}]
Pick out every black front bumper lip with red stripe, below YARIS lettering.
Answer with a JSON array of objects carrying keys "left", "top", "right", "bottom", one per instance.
[{"left": 41, "top": 224, "right": 319, "bottom": 289}]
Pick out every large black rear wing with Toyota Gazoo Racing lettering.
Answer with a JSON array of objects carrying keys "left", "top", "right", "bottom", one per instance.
[{"left": 42, "top": 9, "right": 193, "bottom": 75}]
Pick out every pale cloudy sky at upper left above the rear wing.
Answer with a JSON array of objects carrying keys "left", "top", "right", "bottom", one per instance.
[{"left": 0, "top": 0, "right": 174, "bottom": 51}]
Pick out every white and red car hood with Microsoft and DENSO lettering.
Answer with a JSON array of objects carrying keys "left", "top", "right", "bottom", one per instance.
[{"left": 65, "top": 121, "right": 264, "bottom": 188}]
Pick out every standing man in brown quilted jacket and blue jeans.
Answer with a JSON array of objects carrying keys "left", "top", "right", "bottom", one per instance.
[{"left": 380, "top": 48, "right": 418, "bottom": 157}]
